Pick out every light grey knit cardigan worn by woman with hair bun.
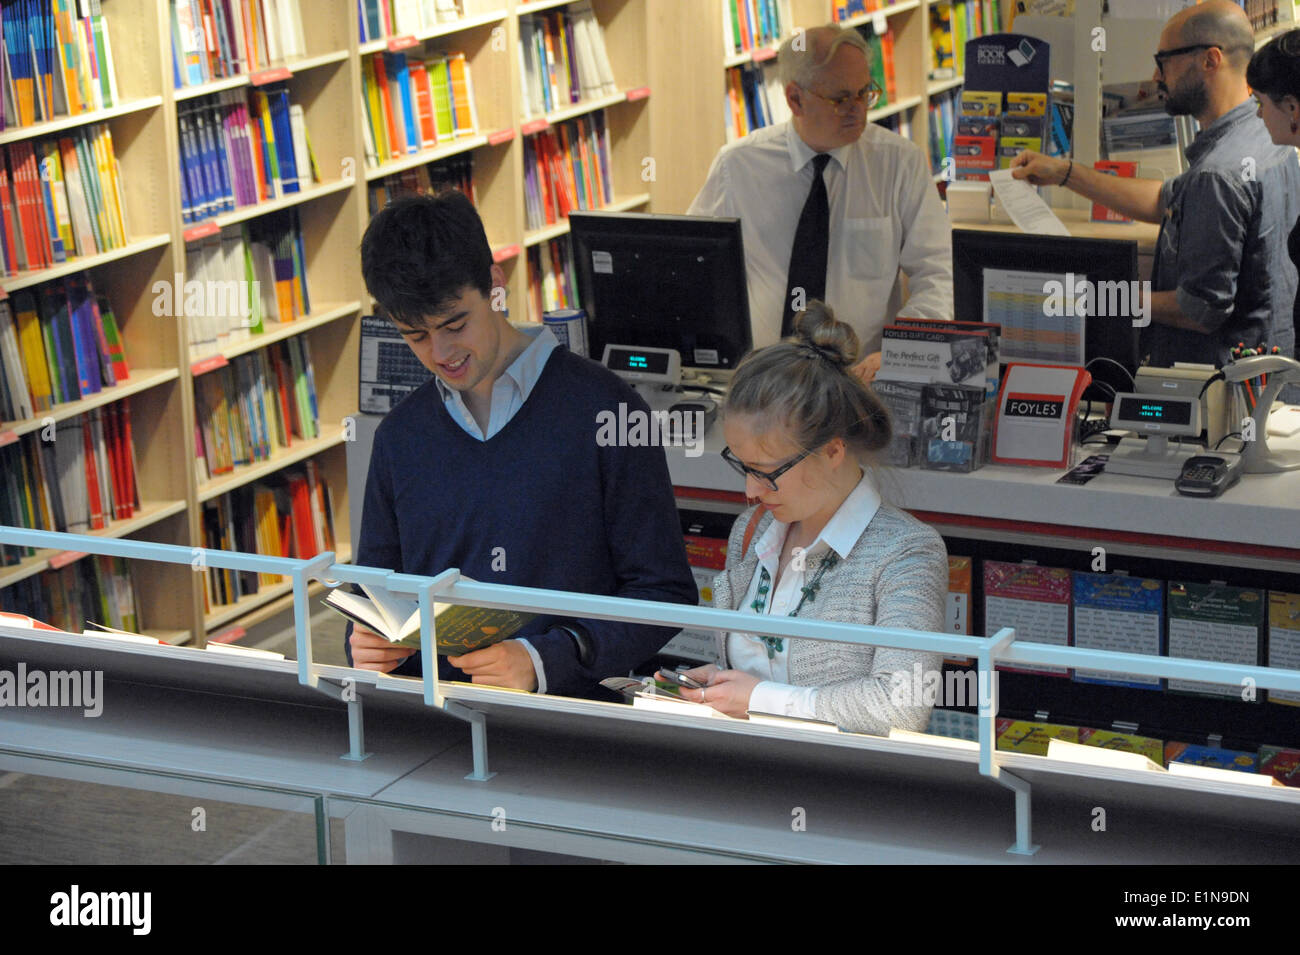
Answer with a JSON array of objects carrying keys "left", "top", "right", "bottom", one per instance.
[{"left": 714, "top": 504, "right": 948, "bottom": 735}]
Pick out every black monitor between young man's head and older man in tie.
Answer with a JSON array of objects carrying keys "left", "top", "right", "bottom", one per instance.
[{"left": 569, "top": 212, "right": 753, "bottom": 372}]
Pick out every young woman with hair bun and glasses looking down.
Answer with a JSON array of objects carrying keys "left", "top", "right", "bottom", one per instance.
[{"left": 665, "top": 301, "right": 948, "bottom": 734}]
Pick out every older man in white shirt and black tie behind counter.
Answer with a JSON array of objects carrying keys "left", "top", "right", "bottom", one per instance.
[{"left": 688, "top": 25, "right": 953, "bottom": 379}]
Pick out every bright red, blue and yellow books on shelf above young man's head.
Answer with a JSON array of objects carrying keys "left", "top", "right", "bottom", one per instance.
[{"left": 361, "top": 48, "right": 478, "bottom": 166}]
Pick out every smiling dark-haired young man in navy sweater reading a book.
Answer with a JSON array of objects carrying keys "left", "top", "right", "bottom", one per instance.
[{"left": 347, "top": 191, "right": 697, "bottom": 696}]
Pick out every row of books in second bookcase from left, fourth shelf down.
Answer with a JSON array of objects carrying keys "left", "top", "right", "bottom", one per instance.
[{"left": 194, "top": 335, "right": 320, "bottom": 481}]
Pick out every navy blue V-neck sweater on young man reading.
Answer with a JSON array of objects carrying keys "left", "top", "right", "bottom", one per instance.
[{"left": 348, "top": 346, "right": 698, "bottom": 696}]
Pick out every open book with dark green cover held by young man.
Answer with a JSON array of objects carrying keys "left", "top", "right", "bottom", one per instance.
[{"left": 325, "top": 583, "right": 537, "bottom": 656}]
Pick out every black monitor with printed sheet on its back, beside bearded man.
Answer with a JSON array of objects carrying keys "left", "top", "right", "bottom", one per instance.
[{"left": 953, "top": 229, "right": 1149, "bottom": 379}]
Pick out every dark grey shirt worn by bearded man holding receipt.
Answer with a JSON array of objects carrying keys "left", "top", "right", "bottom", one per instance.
[{"left": 1141, "top": 100, "right": 1300, "bottom": 365}]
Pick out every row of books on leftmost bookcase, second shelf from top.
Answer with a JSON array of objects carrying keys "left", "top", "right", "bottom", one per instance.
[{"left": 0, "top": 123, "right": 126, "bottom": 275}]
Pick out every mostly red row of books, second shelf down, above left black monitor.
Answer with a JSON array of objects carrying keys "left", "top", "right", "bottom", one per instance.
[{"left": 524, "top": 113, "right": 614, "bottom": 230}]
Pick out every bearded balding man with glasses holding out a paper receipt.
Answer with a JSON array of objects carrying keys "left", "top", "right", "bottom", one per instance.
[{"left": 1011, "top": 0, "right": 1300, "bottom": 366}]
